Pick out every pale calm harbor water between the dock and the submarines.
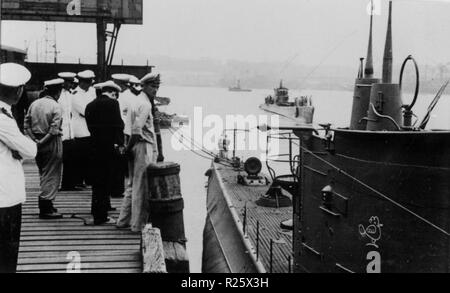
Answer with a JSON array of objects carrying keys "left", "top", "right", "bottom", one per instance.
[{"left": 159, "top": 85, "right": 450, "bottom": 273}]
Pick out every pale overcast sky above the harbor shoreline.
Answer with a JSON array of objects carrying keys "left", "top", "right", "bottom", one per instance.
[{"left": 2, "top": 0, "right": 450, "bottom": 69}]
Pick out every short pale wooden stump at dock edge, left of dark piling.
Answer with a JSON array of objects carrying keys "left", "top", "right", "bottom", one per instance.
[{"left": 141, "top": 225, "right": 167, "bottom": 273}]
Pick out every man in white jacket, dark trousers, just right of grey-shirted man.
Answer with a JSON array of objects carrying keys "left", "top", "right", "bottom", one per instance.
[{"left": 58, "top": 72, "right": 77, "bottom": 191}]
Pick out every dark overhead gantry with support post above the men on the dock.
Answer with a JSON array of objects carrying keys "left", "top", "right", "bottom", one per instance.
[{"left": 0, "top": 0, "right": 143, "bottom": 80}]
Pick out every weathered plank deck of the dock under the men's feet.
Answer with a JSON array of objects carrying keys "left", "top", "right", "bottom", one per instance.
[{"left": 17, "top": 163, "right": 142, "bottom": 273}]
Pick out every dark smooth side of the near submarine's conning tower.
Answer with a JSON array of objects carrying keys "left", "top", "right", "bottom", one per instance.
[{"left": 294, "top": 130, "right": 450, "bottom": 273}]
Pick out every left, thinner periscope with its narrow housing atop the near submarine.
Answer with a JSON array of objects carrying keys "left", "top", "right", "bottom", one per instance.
[{"left": 350, "top": 1, "right": 380, "bottom": 130}]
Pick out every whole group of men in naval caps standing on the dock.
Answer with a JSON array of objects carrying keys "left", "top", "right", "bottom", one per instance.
[{"left": 0, "top": 63, "right": 164, "bottom": 272}]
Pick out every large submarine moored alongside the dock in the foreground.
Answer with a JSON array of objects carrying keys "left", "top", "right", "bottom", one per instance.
[{"left": 203, "top": 1, "right": 450, "bottom": 273}]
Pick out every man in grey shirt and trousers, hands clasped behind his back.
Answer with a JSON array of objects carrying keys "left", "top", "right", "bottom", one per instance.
[{"left": 25, "top": 78, "right": 64, "bottom": 220}]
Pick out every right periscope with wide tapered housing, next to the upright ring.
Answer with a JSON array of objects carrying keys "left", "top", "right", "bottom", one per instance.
[{"left": 365, "top": 1, "right": 403, "bottom": 131}]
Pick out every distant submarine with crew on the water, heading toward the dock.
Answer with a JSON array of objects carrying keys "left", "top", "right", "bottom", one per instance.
[{"left": 259, "top": 81, "right": 314, "bottom": 124}]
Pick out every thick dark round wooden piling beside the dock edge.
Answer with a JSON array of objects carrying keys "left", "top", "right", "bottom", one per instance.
[{"left": 147, "top": 162, "right": 189, "bottom": 273}]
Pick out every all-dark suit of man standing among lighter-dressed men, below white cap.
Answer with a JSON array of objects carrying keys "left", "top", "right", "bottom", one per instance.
[{"left": 86, "top": 95, "right": 124, "bottom": 224}]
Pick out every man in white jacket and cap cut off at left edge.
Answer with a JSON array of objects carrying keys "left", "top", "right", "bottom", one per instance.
[{"left": 0, "top": 63, "right": 37, "bottom": 273}]
